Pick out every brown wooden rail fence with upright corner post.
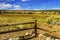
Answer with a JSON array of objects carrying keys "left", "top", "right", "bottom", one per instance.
[{"left": 0, "top": 20, "right": 58, "bottom": 38}]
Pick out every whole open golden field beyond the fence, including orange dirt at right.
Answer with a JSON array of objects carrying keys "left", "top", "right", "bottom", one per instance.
[{"left": 0, "top": 10, "right": 60, "bottom": 39}]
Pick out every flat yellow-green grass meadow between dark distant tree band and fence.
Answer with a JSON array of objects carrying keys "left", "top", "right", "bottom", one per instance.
[{"left": 0, "top": 14, "right": 60, "bottom": 30}]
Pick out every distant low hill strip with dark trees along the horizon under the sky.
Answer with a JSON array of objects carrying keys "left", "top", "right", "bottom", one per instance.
[{"left": 0, "top": 10, "right": 60, "bottom": 14}]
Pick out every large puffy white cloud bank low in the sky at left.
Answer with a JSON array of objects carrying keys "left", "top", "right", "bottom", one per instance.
[{"left": 0, "top": 3, "right": 21, "bottom": 10}]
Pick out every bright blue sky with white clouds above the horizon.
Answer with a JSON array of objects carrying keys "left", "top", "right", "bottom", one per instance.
[{"left": 0, "top": 0, "right": 60, "bottom": 10}]
